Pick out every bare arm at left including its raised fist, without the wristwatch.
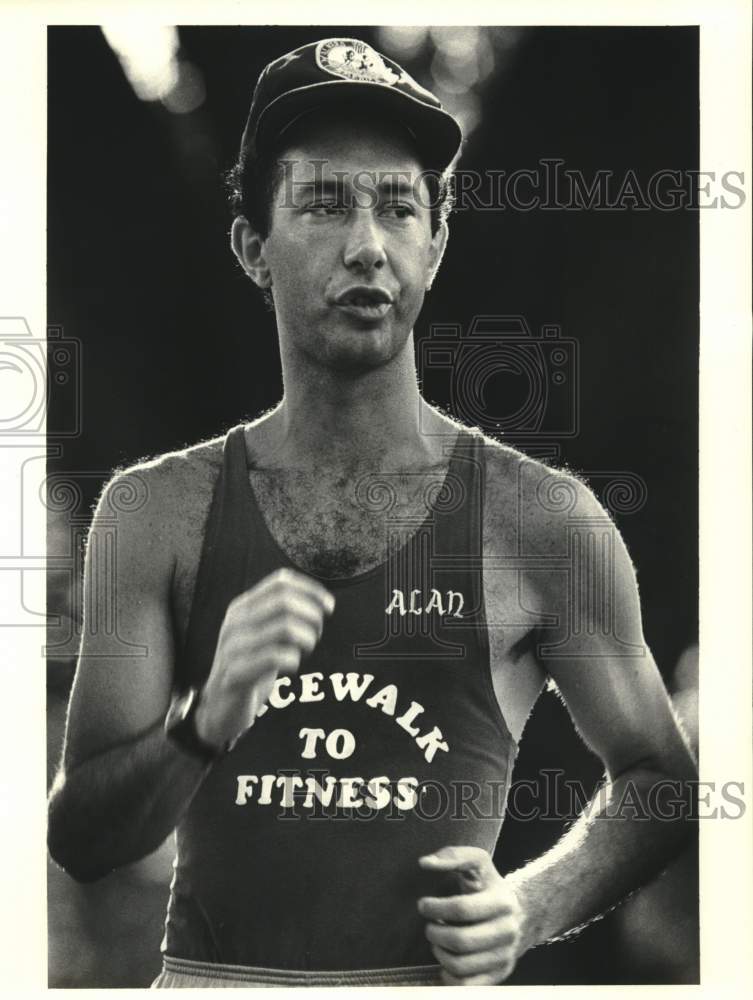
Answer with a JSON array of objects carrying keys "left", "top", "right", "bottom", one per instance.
[{"left": 48, "top": 467, "right": 333, "bottom": 881}]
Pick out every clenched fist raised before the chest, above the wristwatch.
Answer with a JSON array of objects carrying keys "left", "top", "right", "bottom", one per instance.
[{"left": 196, "top": 569, "right": 335, "bottom": 747}]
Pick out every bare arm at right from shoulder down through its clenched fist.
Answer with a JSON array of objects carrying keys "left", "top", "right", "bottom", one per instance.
[{"left": 419, "top": 468, "right": 697, "bottom": 985}]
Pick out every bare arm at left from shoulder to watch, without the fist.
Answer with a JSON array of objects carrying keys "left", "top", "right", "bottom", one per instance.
[{"left": 48, "top": 468, "right": 213, "bottom": 881}]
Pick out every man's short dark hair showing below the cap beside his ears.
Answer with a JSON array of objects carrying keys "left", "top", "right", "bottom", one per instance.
[{"left": 225, "top": 128, "right": 454, "bottom": 311}]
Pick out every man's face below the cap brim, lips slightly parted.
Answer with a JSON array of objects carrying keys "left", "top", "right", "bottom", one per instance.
[{"left": 254, "top": 117, "right": 446, "bottom": 372}]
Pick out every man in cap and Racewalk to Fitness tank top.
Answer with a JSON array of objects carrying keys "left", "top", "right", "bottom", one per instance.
[{"left": 49, "top": 39, "right": 695, "bottom": 987}]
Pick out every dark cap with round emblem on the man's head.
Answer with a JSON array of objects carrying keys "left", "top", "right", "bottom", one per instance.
[{"left": 241, "top": 38, "right": 463, "bottom": 170}]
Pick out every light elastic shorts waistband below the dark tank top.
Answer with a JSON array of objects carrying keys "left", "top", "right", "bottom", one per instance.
[{"left": 162, "top": 955, "right": 440, "bottom": 986}]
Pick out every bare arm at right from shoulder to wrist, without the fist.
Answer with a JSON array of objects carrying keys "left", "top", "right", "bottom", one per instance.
[{"left": 508, "top": 486, "right": 697, "bottom": 951}]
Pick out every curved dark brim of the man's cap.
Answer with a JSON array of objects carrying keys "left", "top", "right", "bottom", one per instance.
[{"left": 250, "top": 80, "right": 463, "bottom": 170}]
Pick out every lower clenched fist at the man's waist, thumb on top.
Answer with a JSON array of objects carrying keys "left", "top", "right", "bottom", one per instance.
[{"left": 418, "top": 847, "right": 523, "bottom": 986}]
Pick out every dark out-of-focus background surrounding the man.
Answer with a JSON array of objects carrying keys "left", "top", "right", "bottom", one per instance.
[{"left": 48, "top": 26, "right": 698, "bottom": 986}]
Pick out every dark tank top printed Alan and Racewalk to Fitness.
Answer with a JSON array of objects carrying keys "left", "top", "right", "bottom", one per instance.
[{"left": 162, "top": 425, "right": 516, "bottom": 970}]
